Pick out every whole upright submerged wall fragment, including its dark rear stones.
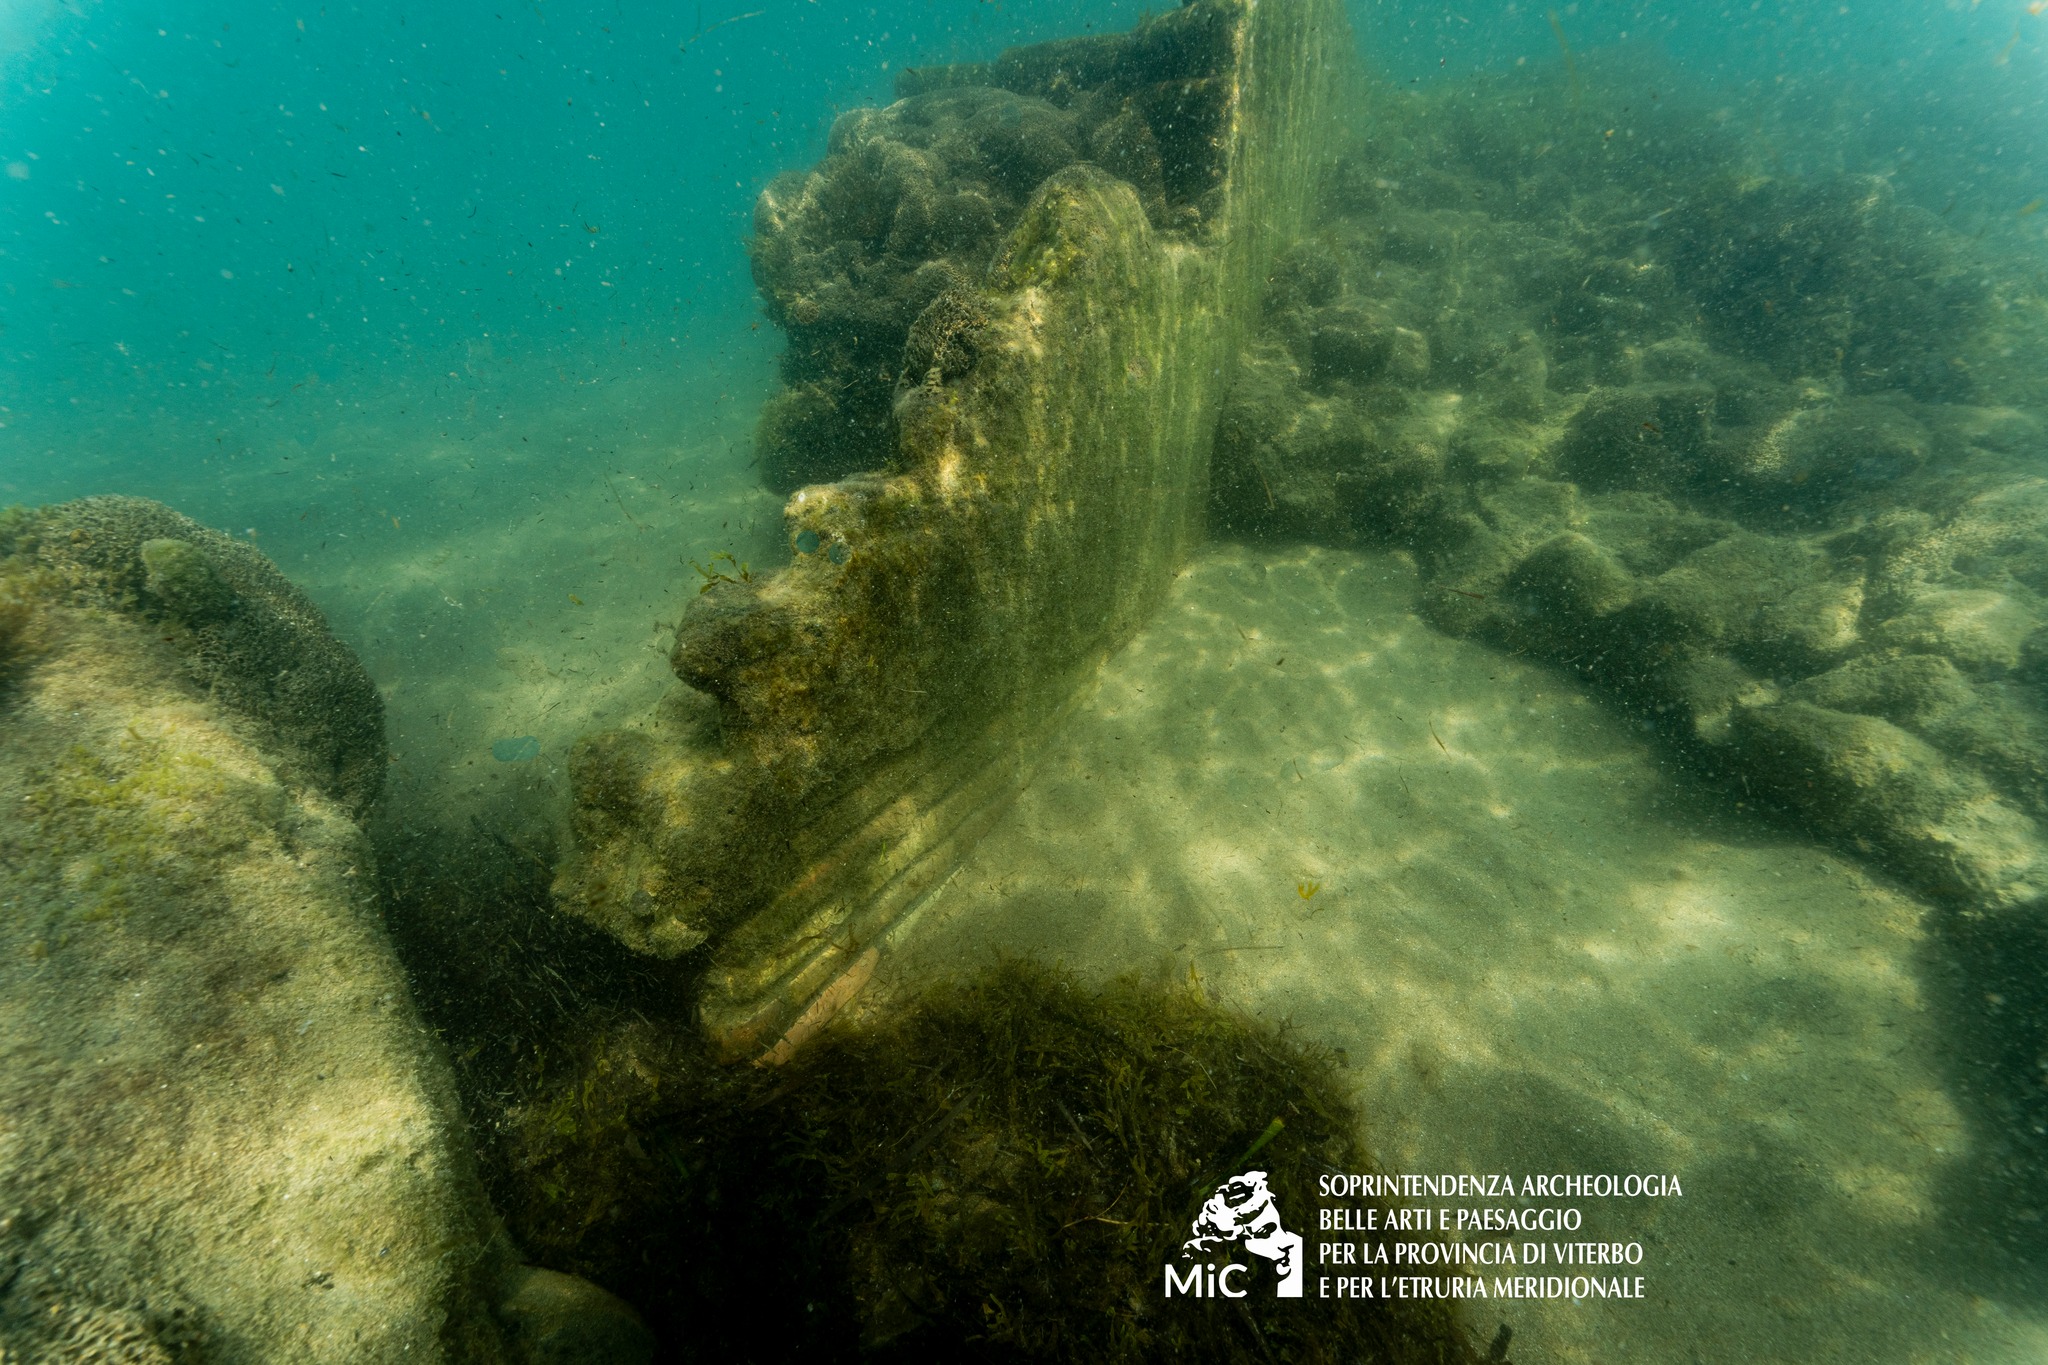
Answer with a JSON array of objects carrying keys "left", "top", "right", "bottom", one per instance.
[{"left": 557, "top": 0, "right": 1350, "bottom": 1052}]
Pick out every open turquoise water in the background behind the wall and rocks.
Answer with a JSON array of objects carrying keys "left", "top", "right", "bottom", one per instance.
[{"left": 0, "top": 2, "right": 2048, "bottom": 822}]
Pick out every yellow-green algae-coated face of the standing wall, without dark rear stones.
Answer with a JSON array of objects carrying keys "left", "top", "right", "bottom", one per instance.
[{"left": 557, "top": 0, "right": 1350, "bottom": 1050}]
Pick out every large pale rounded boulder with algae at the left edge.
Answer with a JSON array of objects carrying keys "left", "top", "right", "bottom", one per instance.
[{"left": 0, "top": 497, "right": 520, "bottom": 1365}]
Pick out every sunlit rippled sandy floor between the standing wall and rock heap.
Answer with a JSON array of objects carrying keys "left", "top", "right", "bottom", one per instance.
[{"left": 885, "top": 548, "right": 2048, "bottom": 1363}]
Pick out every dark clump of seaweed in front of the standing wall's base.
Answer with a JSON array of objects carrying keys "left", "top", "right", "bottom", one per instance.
[{"left": 508, "top": 962, "right": 1479, "bottom": 1361}]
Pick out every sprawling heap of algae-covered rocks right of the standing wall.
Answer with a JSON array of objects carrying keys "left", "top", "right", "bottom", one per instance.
[{"left": 1210, "top": 68, "right": 2048, "bottom": 907}]
